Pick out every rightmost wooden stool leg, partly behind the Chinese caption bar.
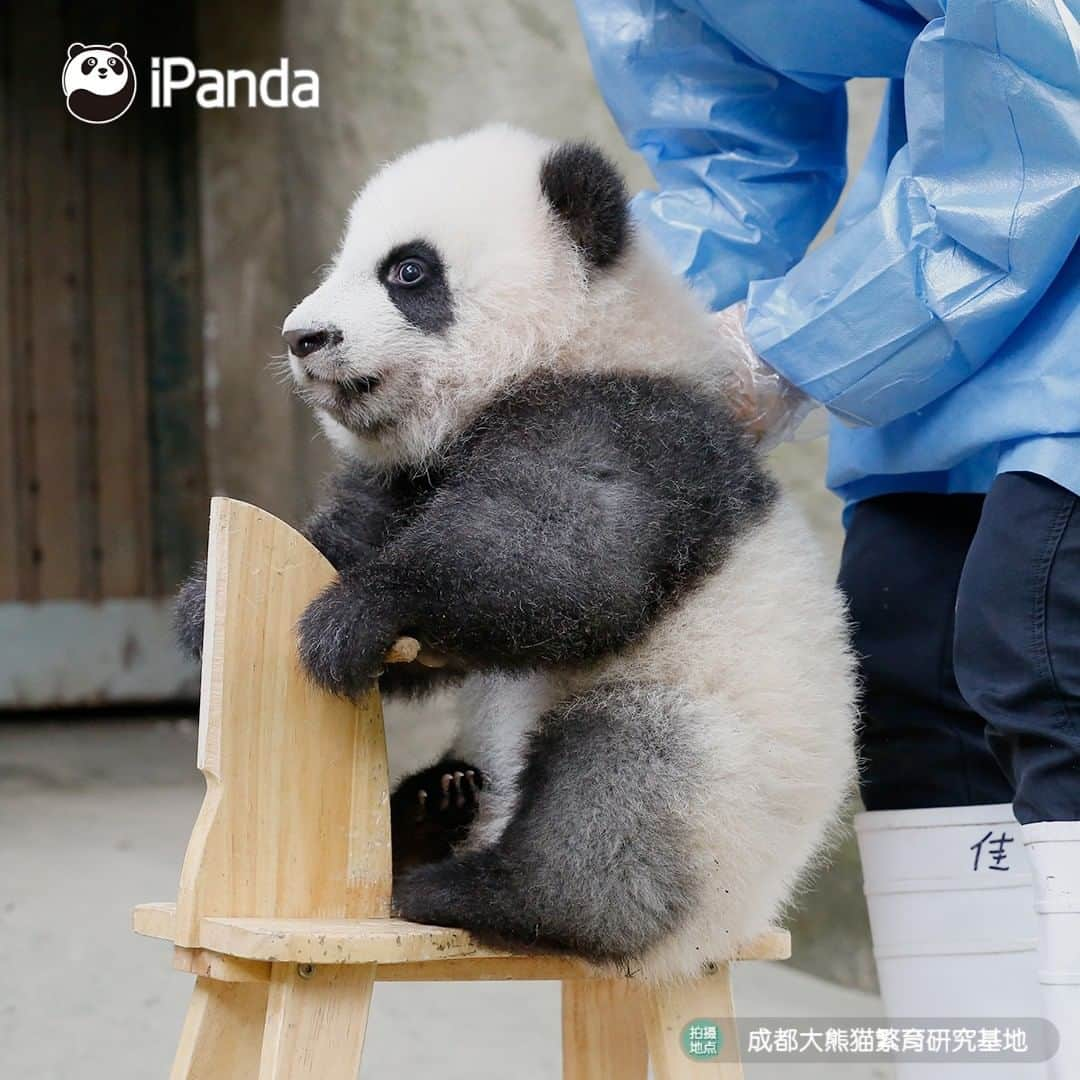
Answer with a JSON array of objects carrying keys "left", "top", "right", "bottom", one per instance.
[{"left": 642, "top": 964, "right": 743, "bottom": 1080}]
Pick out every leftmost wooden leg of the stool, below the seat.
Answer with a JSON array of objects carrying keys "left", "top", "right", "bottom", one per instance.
[{"left": 170, "top": 978, "right": 268, "bottom": 1080}]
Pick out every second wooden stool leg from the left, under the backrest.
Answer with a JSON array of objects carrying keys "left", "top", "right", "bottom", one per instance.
[{"left": 258, "top": 963, "right": 375, "bottom": 1080}]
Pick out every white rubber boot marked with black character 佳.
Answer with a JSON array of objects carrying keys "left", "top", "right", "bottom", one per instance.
[{"left": 855, "top": 804, "right": 1047, "bottom": 1080}]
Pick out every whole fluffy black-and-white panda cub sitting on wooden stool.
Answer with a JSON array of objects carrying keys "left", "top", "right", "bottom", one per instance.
[{"left": 174, "top": 126, "right": 853, "bottom": 978}]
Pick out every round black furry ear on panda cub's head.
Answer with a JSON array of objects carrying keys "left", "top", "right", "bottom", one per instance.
[{"left": 540, "top": 143, "right": 630, "bottom": 269}]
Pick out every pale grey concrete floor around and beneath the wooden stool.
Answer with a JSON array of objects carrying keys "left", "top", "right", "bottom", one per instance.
[{"left": 0, "top": 720, "right": 891, "bottom": 1080}]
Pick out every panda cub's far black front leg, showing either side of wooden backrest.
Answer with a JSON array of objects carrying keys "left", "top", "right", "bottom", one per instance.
[{"left": 173, "top": 464, "right": 401, "bottom": 666}]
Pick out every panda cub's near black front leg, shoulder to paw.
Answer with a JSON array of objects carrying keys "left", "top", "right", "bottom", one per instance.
[{"left": 300, "top": 375, "right": 775, "bottom": 694}]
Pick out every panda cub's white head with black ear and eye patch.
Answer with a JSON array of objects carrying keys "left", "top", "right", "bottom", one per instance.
[{"left": 283, "top": 125, "right": 707, "bottom": 468}]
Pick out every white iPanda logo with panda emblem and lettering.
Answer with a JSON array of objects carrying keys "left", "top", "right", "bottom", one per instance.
[{"left": 60, "top": 41, "right": 319, "bottom": 124}]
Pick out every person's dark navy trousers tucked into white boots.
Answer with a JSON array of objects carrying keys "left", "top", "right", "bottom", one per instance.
[{"left": 840, "top": 473, "right": 1080, "bottom": 824}]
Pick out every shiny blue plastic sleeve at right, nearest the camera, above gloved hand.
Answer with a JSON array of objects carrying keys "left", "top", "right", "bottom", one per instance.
[{"left": 746, "top": 0, "right": 1080, "bottom": 424}]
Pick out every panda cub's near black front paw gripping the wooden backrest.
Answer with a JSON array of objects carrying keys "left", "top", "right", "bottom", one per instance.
[{"left": 297, "top": 580, "right": 397, "bottom": 698}]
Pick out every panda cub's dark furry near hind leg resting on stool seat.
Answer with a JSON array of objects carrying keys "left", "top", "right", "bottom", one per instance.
[{"left": 394, "top": 685, "right": 697, "bottom": 962}]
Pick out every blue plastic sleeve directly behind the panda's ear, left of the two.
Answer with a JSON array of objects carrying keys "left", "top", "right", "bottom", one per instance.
[{"left": 578, "top": 0, "right": 847, "bottom": 308}]
